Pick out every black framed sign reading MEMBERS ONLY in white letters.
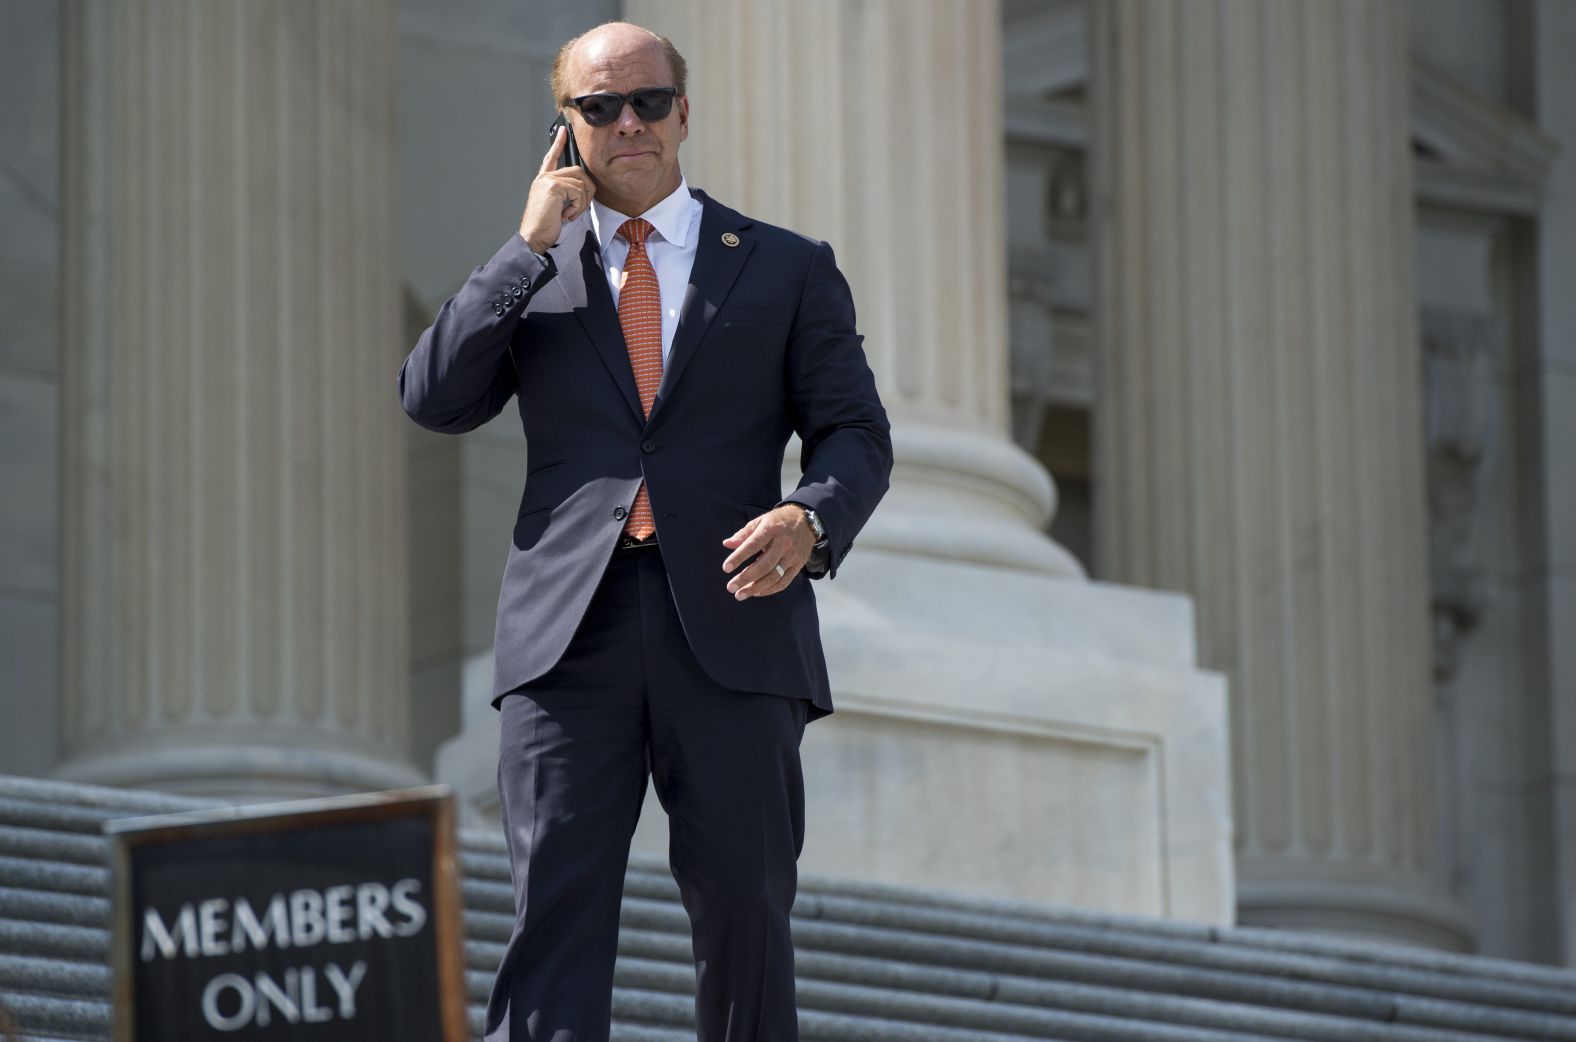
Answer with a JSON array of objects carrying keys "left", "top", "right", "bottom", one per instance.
[{"left": 104, "top": 788, "right": 466, "bottom": 1042}]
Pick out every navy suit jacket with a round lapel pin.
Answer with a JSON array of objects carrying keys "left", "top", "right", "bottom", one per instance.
[{"left": 399, "top": 189, "right": 892, "bottom": 716}]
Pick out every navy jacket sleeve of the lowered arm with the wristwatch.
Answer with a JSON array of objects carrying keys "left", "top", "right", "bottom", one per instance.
[{"left": 783, "top": 243, "right": 892, "bottom": 579}]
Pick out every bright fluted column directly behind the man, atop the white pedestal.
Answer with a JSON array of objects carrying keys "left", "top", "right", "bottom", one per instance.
[{"left": 624, "top": 0, "right": 1081, "bottom": 575}]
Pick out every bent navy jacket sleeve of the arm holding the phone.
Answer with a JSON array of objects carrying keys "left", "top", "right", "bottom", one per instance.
[{"left": 399, "top": 233, "right": 558, "bottom": 434}]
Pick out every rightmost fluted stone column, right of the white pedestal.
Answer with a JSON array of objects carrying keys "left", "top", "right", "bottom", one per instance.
[{"left": 1091, "top": 0, "right": 1469, "bottom": 947}]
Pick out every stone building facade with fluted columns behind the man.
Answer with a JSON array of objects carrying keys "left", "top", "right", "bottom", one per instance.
[{"left": 0, "top": 0, "right": 1576, "bottom": 963}]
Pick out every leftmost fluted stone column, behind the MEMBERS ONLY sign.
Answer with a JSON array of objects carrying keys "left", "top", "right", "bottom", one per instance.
[{"left": 58, "top": 0, "right": 419, "bottom": 799}]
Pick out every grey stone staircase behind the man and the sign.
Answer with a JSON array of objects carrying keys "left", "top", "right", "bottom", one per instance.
[{"left": 0, "top": 777, "right": 1576, "bottom": 1042}]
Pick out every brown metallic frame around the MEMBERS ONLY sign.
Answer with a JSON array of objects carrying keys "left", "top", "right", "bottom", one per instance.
[{"left": 102, "top": 785, "right": 470, "bottom": 1042}]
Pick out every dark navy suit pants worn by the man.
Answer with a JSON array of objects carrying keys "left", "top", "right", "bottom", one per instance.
[{"left": 487, "top": 547, "right": 808, "bottom": 1042}]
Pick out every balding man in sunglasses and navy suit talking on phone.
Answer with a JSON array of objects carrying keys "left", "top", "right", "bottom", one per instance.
[{"left": 400, "top": 22, "right": 892, "bottom": 1042}]
